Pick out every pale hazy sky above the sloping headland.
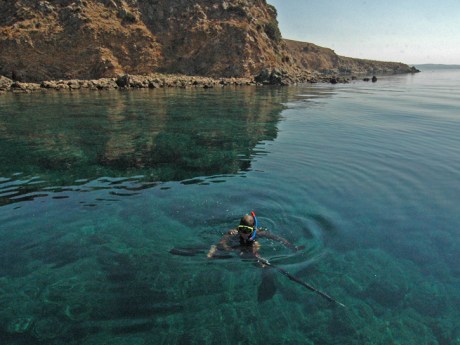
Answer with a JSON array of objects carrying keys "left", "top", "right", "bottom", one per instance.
[{"left": 267, "top": 0, "right": 460, "bottom": 64}]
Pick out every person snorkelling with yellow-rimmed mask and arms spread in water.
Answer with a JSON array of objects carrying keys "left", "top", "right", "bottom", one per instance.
[{"left": 207, "top": 212, "right": 301, "bottom": 259}]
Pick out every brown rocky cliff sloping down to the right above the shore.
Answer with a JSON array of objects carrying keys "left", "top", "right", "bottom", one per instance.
[{"left": 0, "top": 0, "right": 416, "bottom": 81}]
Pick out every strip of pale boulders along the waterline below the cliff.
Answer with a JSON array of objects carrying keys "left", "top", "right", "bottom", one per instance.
[{"left": 0, "top": 69, "right": 416, "bottom": 94}]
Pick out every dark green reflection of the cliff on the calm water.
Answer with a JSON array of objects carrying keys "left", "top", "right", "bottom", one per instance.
[{"left": 0, "top": 87, "right": 298, "bottom": 204}]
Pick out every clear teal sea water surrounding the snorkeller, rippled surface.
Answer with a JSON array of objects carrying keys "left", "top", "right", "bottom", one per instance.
[{"left": 0, "top": 70, "right": 460, "bottom": 345}]
